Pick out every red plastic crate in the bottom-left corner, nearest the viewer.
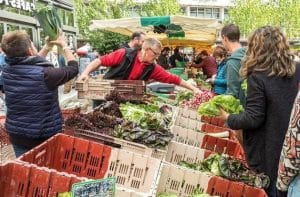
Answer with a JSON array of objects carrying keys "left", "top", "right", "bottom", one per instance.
[{"left": 0, "top": 162, "right": 86, "bottom": 197}]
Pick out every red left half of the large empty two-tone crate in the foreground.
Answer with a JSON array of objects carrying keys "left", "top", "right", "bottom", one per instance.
[{"left": 19, "top": 134, "right": 111, "bottom": 179}]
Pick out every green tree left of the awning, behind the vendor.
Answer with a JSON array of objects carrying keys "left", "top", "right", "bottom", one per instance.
[{"left": 74, "top": 0, "right": 132, "bottom": 54}]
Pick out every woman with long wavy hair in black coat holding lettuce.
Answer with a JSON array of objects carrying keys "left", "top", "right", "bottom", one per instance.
[{"left": 220, "top": 26, "right": 297, "bottom": 197}]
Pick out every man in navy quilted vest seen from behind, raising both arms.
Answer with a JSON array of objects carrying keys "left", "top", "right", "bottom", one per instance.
[{"left": 1, "top": 31, "right": 78, "bottom": 157}]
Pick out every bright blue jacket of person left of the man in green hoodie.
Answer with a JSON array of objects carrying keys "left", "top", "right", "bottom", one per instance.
[{"left": 214, "top": 60, "right": 227, "bottom": 94}]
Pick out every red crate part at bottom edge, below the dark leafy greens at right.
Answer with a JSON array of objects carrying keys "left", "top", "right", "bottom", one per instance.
[{"left": 207, "top": 176, "right": 267, "bottom": 197}]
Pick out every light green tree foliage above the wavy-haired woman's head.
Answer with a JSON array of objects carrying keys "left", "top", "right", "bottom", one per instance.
[{"left": 227, "top": 0, "right": 300, "bottom": 39}]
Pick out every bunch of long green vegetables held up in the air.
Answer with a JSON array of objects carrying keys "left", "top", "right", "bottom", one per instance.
[{"left": 35, "top": 5, "right": 62, "bottom": 40}]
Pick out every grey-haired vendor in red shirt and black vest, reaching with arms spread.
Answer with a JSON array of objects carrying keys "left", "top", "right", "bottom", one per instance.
[{"left": 79, "top": 38, "right": 200, "bottom": 92}]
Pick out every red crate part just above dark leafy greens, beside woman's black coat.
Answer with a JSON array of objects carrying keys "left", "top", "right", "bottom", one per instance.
[{"left": 200, "top": 135, "right": 245, "bottom": 160}]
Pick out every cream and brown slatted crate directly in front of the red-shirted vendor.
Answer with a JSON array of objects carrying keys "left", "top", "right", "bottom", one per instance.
[{"left": 75, "top": 78, "right": 146, "bottom": 101}]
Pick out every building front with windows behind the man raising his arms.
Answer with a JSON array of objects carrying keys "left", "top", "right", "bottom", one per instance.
[{"left": 0, "top": 0, "right": 78, "bottom": 49}]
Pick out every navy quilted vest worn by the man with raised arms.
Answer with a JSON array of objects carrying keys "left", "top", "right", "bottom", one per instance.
[{"left": 3, "top": 57, "right": 63, "bottom": 139}]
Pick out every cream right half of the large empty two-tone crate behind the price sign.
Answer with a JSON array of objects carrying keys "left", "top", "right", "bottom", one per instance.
[{"left": 105, "top": 148, "right": 161, "bottom": 197}]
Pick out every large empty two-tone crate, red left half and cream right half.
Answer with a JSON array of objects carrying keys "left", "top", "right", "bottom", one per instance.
[{"left": 18, "top": 134, "right": 161, "bottom": 196}]
